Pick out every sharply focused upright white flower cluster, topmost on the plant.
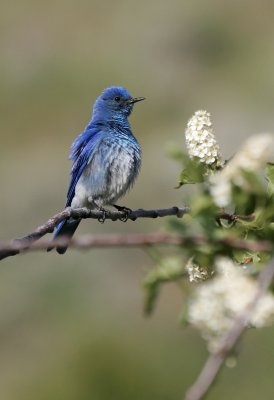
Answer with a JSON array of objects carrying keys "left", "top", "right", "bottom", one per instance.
[{"left": 185, "top": 110, "right": 223, "bottom": 168}]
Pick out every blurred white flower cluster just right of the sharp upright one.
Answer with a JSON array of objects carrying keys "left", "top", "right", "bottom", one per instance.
[{"left": 210, "top": 133, "right": 274, "bottom": 207}]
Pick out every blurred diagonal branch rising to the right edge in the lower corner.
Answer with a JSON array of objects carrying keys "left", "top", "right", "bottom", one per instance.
[{"left": 185, "top": 260, "right": 274, "bottom": 400}]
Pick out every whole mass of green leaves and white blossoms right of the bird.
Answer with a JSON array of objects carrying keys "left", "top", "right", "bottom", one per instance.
[{"left": 145, "top": 120, "right": 274, "bottom": 352}]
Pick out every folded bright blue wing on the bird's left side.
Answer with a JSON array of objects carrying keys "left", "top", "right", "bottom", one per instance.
[{"left": 66, "top": 126, "right": 102, "bottom": 207}]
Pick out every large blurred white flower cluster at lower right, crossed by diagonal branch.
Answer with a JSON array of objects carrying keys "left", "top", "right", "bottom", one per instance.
[{"left": 188, "top": 258, "right": 274, "bottom": 352}]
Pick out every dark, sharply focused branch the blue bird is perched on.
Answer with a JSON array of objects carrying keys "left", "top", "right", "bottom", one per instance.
[{"left": 0, "top": 207, "right": 189, "bottom": 260}]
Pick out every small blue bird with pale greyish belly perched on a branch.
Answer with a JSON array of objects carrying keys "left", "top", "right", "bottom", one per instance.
[{"left": 48, "top": 86, "right": 145, "bottom": 254}]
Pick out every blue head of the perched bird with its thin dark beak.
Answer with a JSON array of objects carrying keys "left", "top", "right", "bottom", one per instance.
[{"left": 93, "top": 86, "right": 145, "bottom": 119}]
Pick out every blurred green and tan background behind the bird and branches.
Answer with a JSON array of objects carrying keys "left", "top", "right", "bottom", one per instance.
[{"left": 0, "top": 0, "right": 274, "bottom": 400}]
